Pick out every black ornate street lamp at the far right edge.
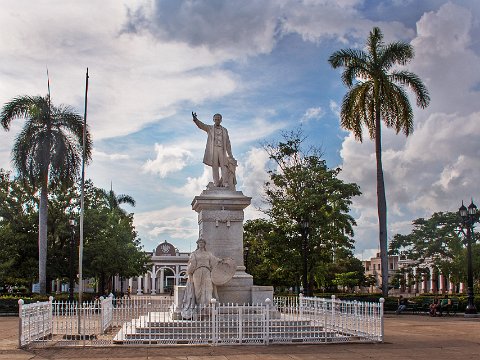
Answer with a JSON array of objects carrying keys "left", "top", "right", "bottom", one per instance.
[{"left": 458, "top": 200, "right": 479, "bottom": 315}]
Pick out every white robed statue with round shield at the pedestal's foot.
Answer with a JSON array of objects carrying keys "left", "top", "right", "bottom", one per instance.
[{"left": 181, "top": 238, "right": 221, "bottom": 319}]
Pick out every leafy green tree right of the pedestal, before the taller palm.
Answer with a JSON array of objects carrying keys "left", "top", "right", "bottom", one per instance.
[{"left": 265, "top": 131, "right": 360, "bottom": 295}]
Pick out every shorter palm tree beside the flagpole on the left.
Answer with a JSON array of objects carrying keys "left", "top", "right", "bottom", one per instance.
[{"left": 0, "top": 95, "right": 92, "bottom": 294}]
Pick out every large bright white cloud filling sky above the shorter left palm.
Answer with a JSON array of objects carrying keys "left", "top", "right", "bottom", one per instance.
[{"left": 0, "top": 1, "right": 237, "bottom": 140}]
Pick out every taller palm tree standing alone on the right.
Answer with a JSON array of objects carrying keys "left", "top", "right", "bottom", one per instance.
[{"left": 328, "top": 27, "right": 430, "bottom": 296}]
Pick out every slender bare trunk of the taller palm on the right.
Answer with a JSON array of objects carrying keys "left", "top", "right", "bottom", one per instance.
[{"left": 375, "top": 107, "right": 388, "bottom": 297}]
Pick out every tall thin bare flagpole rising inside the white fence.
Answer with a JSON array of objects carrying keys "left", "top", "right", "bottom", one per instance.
[{"left": 78, "top": 68, "right": 88, "bottom": 334}]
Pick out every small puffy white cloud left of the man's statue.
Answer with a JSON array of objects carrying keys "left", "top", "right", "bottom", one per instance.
[{"left": 143, "top": 144, "right": 192, "bottom": 178}]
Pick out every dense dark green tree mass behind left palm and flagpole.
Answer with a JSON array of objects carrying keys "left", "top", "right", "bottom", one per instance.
[{"left": 0, "top": 169, "right": 149, "bottom": 293}]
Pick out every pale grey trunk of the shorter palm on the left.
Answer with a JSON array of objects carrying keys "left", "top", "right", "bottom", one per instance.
[{"left": 38, "top": 182, "right": 48, "bottom": 295}]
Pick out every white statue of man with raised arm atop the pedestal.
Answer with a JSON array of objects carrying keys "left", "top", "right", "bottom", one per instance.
[{"left": 192, "top": 112, "right": 236, "bottom": 190}]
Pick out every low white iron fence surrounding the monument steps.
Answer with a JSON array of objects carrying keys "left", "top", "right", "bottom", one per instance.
[{"left": 19, "top": 296, "right": 383, "bottom": 347}]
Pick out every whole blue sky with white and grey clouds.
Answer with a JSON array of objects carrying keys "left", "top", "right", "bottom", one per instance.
[{"left": 0, "top": 0, "right": 480, "bottom": 258}]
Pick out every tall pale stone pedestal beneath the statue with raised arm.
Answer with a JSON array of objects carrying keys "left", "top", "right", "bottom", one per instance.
[{"left": 192, "top": 183, "right": 273, "bottom": 304}]
